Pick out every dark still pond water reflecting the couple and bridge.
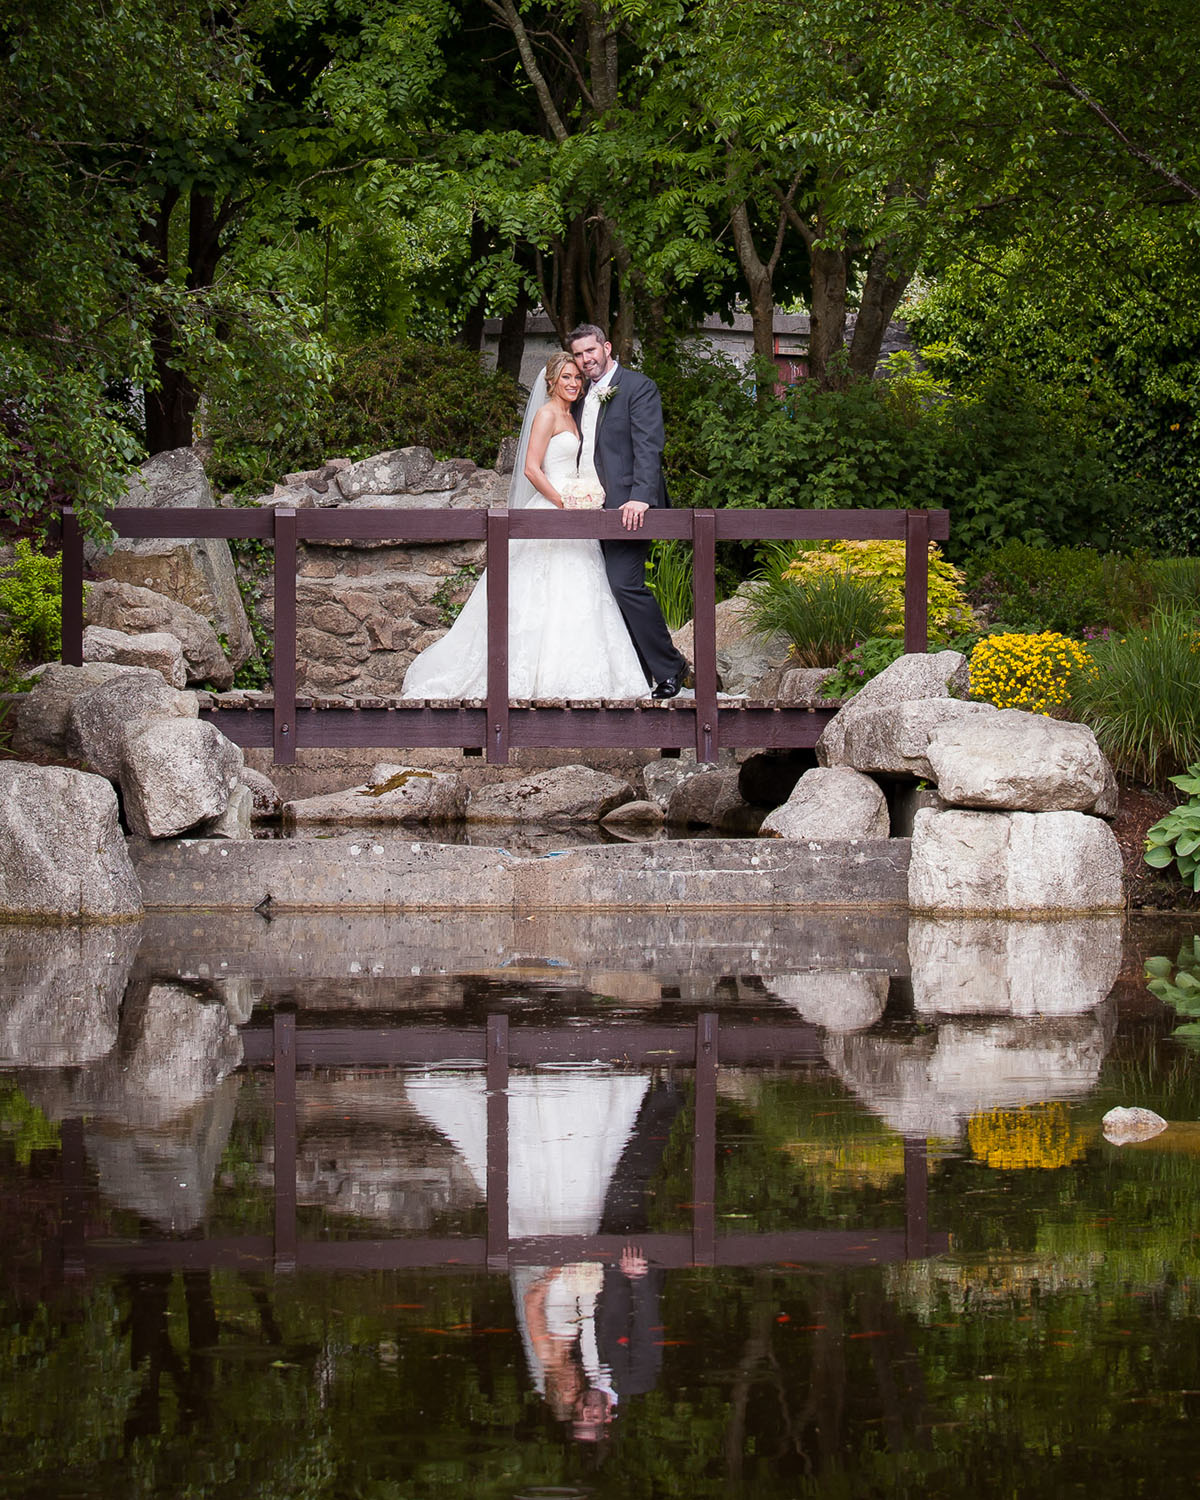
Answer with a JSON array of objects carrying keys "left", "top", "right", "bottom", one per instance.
[{"left": 0, "top": 914, "right": 1200, "bottom": 1500}]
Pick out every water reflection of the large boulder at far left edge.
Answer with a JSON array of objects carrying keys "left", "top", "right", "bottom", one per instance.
[{"left": 0, "top": 923, "right": 141, "bottom": 1068}]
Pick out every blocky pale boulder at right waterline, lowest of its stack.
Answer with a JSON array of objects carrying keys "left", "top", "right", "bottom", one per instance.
[{"left": 909, "top": 810, "right": 1124, "bottom": 915}]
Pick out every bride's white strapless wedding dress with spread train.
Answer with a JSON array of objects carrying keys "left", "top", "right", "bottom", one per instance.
[{"left": 404, "top": 432, "right": 650, "bottom": 699}]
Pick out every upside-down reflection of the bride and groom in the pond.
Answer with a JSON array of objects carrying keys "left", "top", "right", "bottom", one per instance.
[{"left": 405, "top": 1067, "right": 681, "bottom": 1442}]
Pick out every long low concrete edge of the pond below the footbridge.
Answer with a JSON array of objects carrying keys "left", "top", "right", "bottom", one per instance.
[{"left": 129, "top": 830, "right": 909, "bottom": 912}]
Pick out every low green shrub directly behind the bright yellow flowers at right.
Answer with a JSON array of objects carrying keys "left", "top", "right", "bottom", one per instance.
[{"left": 966, "top": 540, "right": 1173, "bottom": 636}]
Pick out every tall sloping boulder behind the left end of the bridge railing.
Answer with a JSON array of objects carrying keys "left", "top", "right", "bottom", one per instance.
[{"left": 87, "top": 449, "right": 254, "bottom": 668}]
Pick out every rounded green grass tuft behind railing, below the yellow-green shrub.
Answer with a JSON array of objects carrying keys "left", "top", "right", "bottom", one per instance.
[{"left": 744, "top": 567, "right": 888, "bottom": 666}]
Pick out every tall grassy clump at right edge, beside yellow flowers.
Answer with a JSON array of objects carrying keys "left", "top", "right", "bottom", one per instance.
[{"left": 1070, "top": 609, "right": 1200, "bottom": 786}]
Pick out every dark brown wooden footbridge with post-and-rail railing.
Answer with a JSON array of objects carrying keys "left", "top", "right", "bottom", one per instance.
[{"left": 63, "top": 506, "right": 950, "bottom": 765}]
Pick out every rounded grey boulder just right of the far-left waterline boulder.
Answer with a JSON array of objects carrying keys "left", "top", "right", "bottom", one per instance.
[{"left": 120, "top": 719, "right": 243, "bottom": 839}]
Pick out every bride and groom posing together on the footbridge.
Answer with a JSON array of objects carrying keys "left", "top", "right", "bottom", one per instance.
[{"left": 404, "top": 324, "right": 689, "bottom": 699}]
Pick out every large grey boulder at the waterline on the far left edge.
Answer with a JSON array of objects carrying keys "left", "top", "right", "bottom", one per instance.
[{"left": 0, "top": 761, "right": 143, "bottom": 923}]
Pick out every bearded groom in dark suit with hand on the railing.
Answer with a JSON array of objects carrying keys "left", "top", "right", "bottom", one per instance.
[{"left": 567, "top": 323, "right": 687, "bottom": 698}]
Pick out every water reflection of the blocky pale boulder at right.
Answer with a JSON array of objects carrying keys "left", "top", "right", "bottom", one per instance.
[{"left": 909, "top": 917, "right": 1122, "bottom": 1016}]
